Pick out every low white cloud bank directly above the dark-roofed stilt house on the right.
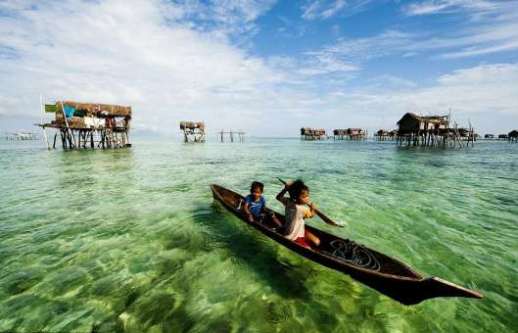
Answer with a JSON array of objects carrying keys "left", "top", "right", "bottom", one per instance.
[{"left": 322, "top": 63, "right": 518, "bottom": 132}]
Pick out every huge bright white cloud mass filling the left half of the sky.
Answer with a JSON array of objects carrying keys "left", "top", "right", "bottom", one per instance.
[{"left": 0, "top": 0, "right": 289, "bottom": 133}]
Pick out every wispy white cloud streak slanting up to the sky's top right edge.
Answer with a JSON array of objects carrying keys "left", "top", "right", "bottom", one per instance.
[{"left": 313, "top": 2, "right": 518, "bottom": 62}]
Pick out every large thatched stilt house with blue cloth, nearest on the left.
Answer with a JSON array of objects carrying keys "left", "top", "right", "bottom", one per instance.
[{"left": 36, "top": 101, "right": 131, "bottom": 150}]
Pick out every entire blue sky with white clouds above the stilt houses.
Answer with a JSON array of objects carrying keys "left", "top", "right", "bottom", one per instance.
[{"left": 0, "top": 0, "right": 518, "bottom": 137}]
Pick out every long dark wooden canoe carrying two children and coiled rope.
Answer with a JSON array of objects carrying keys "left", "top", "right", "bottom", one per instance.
[{"left": 211, "top": 185, "right": 482, "bottom": 305}]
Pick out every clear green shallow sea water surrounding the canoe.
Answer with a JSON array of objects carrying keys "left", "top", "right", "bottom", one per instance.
[{"left": 0, "top": 139, "right": 518, "bottom": 332}]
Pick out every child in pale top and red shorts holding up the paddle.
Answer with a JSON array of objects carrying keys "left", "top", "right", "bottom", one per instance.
[{"left": 276, "top": 180, "right": 320, "bottom": 248}]
